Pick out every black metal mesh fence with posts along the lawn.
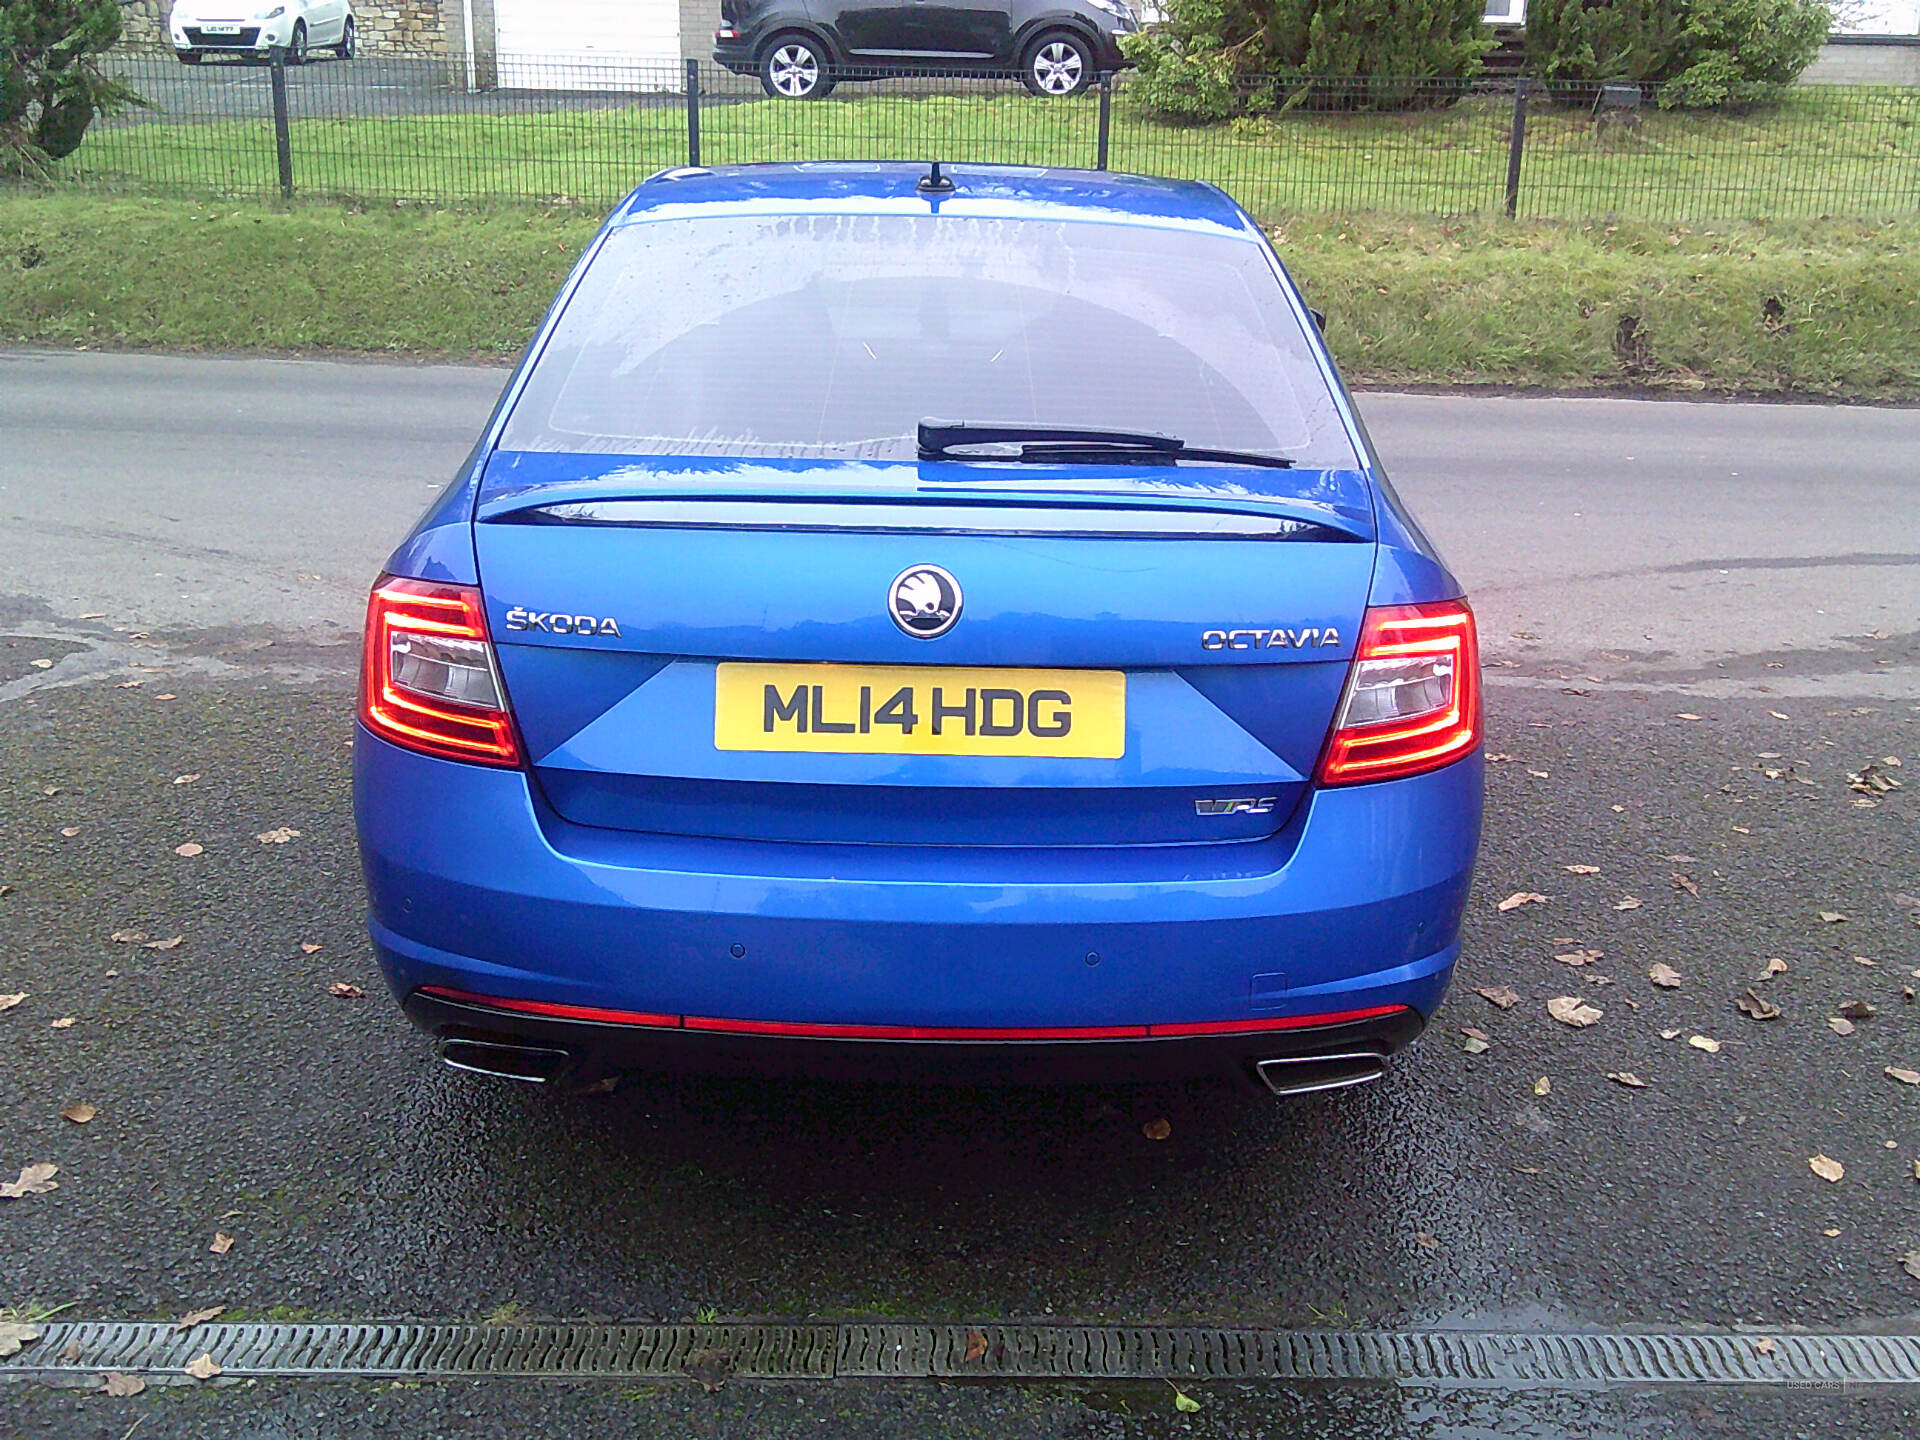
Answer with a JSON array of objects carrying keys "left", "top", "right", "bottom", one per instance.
[{"left": 41, "top": 52, "right": 1920, "bottom": 223}]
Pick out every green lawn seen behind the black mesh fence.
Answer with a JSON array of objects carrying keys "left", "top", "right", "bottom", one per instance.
[{"left": 52, "top": 86, "right": 1920, "bottom": 223}]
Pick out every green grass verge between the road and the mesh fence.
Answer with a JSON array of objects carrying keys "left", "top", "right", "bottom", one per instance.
[{"left": 0, "top": 192, "right": 1920, "bottom": 399}]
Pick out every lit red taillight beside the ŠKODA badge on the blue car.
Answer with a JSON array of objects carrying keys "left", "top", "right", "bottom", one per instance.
[{"left": 361, "top": 576, "right": 520, "bottom": 764}]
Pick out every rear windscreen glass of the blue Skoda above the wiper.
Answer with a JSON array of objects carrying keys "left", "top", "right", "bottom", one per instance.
[{"left": 501, "top": 213, "right": 1356, "bottom": 468}]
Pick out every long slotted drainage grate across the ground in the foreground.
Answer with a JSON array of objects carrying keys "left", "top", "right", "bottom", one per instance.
[{"left": 0, "top": 1321, "right": 1920, "bottom": 1388}]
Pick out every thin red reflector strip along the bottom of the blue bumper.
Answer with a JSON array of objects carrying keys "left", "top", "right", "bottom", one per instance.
[{"left": 420, "top": 985, "right": 1407, "bottom": 1041}]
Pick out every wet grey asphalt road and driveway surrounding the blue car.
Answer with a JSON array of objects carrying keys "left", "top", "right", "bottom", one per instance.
[{"left": 0, "top": 355, "right": 1920, "bottom": 1436}]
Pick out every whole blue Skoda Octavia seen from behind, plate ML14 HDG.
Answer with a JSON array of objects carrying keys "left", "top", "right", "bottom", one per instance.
[{"left": 355, "top": 163, "right": 1482, "bottom": 1094}]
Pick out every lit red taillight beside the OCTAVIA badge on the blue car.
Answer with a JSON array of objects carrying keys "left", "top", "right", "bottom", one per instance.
[{"left": 1319, "top": 601, "right": 1480, "bottom": 785}]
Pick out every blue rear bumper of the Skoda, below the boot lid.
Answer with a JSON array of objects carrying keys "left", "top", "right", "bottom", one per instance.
[{"left": 355, "top": 732, "right": 1482, "bottom": 1075}]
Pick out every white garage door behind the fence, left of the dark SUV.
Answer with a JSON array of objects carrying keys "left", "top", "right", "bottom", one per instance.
[{"left": 493, "top": 0, "right": 685, "bottom": 90}]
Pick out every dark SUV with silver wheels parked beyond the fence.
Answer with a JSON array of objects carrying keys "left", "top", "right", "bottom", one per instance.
[{"left": 714, "top": 0, "right": 1140, "bottom": 100}]
